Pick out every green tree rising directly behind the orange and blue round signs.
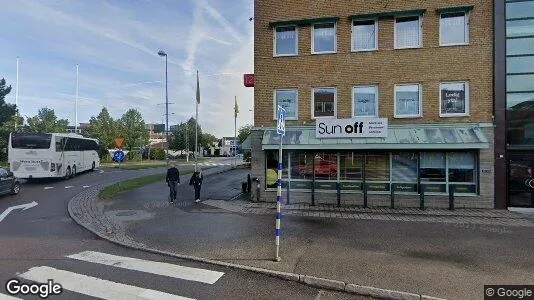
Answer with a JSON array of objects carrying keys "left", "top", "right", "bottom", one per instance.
[{"left": 117, "top": 108, "right": 150, "bottom": 151}]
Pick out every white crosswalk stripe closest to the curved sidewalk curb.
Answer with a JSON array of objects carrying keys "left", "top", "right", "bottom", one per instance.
[{"left": 67, "top": 251, "right": 224, "bottom": 284}]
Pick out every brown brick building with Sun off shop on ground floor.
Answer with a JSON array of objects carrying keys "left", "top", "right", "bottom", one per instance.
[{"left": 251, "top": 0, "right": 495, "bottom": 208}]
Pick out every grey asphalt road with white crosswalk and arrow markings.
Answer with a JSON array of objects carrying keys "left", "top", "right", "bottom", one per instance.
[{"left": 0, "top": 158, "right": 363, "bottom": 299}]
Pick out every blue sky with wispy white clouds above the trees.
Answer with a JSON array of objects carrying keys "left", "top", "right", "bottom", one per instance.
[{"left": 0, "top": 0, "right": 254, "bottom": 137}]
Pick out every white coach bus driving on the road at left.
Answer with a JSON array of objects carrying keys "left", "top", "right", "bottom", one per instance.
[{"left": 8, "top": 133, "right": 100, "bottom": 179}]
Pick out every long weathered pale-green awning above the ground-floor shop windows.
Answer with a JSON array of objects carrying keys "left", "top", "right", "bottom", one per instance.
[{"left": 262, "top": 124, "right": 491, "bottom": 150}]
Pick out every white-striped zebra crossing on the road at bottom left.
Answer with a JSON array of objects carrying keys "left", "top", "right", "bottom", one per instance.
[{"left": 0, "top": 251, "right": 224, "bottom": 300}]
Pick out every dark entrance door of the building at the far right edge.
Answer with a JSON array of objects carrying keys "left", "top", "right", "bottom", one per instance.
[{"left": 508, "top": 151, "right": 534, "bottom": 207}]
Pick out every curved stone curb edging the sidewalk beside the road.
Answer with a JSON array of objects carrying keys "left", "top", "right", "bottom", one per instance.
[{"left": 67, "top": 168, "right": 445, "bottom": 300}]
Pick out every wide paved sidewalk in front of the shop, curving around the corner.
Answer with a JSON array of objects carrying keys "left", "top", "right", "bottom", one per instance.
[{"left": 69, "top": 168, "right": 534, "bottom": 299}]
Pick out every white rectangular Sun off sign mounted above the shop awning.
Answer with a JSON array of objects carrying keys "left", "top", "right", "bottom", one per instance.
[{"left": 315, "top": 118, "right": 388, "bottom": 138}]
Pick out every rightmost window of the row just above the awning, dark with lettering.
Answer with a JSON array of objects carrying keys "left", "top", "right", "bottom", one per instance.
[{"left": 439, "top": 82, "right": 469, "bottom": 117}]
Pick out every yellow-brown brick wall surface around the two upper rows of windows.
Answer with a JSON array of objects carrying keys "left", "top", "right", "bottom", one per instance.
[{"left": 254, "top": 0, "right": 493, "bottom": 126}]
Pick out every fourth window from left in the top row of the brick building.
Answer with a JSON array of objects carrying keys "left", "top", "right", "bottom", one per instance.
[{"left": 395, "top": 16, "right": 422, "bottom": 49}]
